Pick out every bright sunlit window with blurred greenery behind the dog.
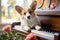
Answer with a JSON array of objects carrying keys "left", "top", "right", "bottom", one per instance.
[{"left": 1, "top": 0, "right": 32, "bottom": 23}]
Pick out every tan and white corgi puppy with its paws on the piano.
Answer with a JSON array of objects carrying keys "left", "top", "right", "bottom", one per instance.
[{"left": 15, "top": 1, "right": 41, "bottom": 31}]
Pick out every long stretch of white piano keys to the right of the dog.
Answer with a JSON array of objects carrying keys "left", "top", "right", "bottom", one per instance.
[{"left": 31, "top": 30, "right": 58, "bottom": 40}]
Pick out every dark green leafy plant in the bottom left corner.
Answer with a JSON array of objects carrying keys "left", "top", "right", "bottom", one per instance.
[{"left": 0, "top": 30, "right": 24, "bottom": 40}]
